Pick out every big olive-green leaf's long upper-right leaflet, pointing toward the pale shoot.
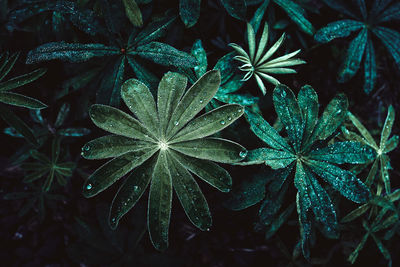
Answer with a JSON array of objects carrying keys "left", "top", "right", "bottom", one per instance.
[{"left": 166, "top": 70, "right": 221, "bottom": 139}]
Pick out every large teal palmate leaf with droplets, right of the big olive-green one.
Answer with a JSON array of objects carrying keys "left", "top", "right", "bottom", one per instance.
[{"left": 234, "top": 85, "right": 376, "bottom": 257}]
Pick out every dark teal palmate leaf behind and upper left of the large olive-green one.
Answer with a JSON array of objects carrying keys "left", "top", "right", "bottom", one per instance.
[{"left": 27, "top": 15, "right": 197, "bottom": 106}]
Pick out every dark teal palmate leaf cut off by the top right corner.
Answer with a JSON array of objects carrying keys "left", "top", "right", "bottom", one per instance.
[{"left": 314, "top": 0, "right": 400, "bottom": 94}]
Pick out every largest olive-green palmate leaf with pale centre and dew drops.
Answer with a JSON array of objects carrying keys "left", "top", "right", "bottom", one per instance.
[{"left": 82, "top": 70, "right": 246, "bottom": 250}]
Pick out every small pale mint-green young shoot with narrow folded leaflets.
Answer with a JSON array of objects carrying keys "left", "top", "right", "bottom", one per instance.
[{"left": 230, "top": 23, "right": 306, "bottom": 95}]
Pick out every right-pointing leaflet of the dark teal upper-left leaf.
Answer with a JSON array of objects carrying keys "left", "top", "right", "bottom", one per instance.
[{"left": 134, "top": 42, "right": 198, "bottom": 68}]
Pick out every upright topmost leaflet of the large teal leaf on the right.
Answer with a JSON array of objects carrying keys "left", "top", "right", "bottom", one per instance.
[{"left": 297, "top": 85, "right": 318, "bottom": 147}]
